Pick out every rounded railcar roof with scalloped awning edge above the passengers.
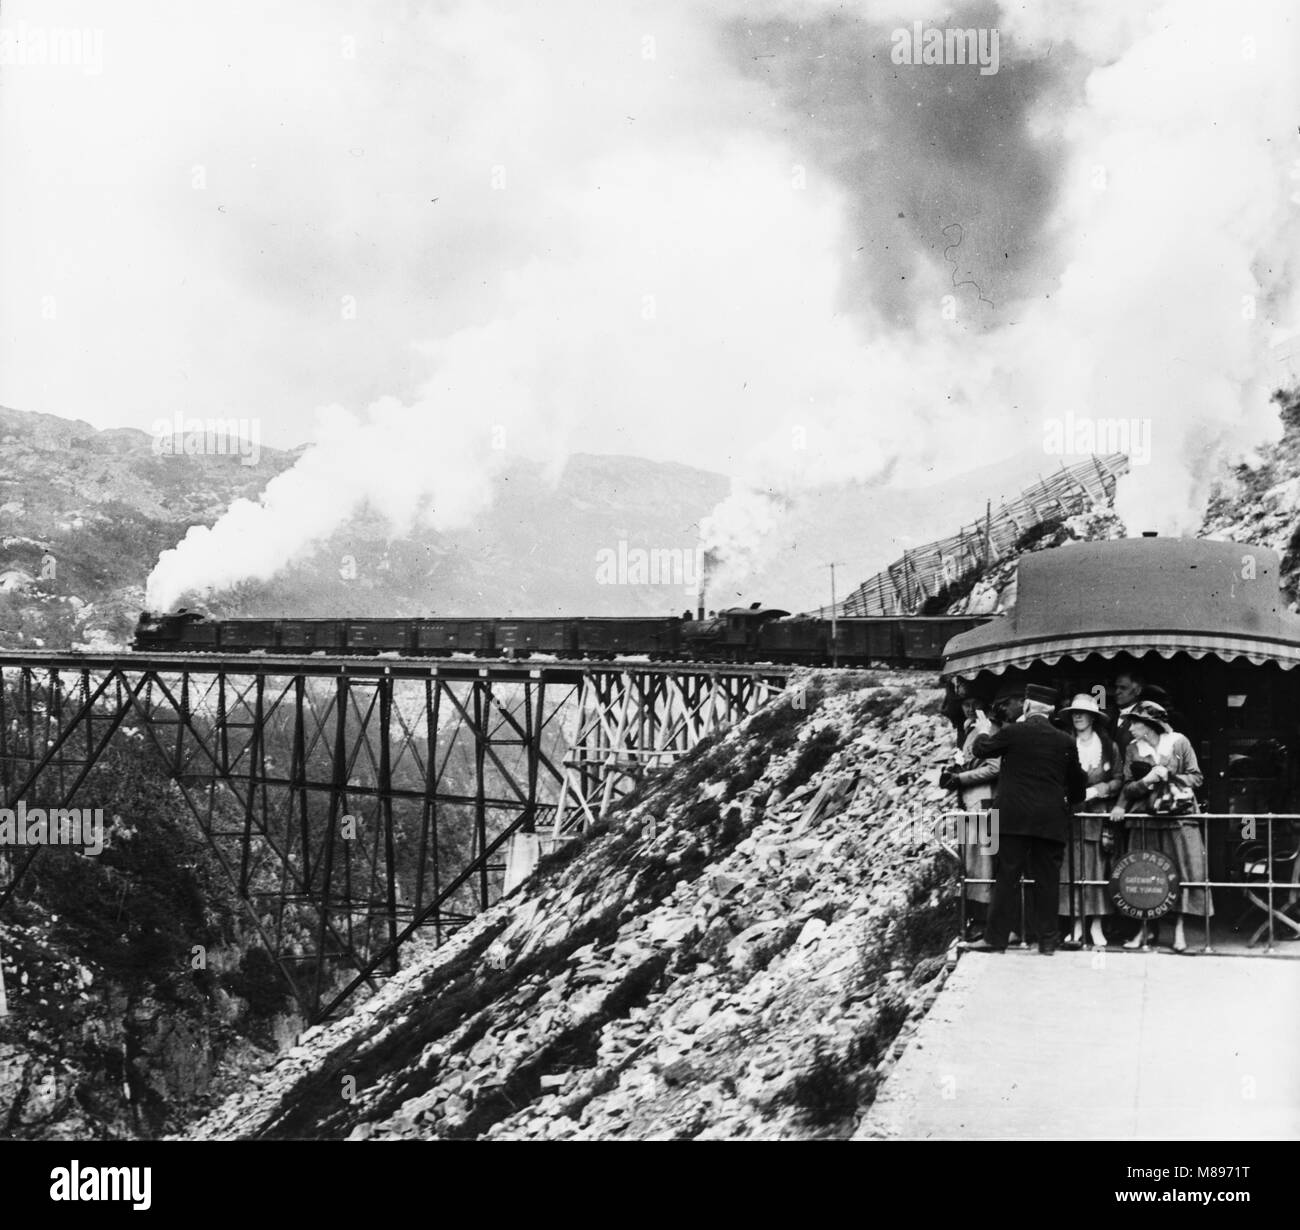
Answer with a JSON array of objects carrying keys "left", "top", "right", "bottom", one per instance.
[{"left": 944, "top": 538, "right": 1300, "bottom": 679}]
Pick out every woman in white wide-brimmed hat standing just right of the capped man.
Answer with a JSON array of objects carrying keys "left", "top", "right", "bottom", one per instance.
[{"left": 1060, "top": 692, "right": 1123, "bottom": 948}]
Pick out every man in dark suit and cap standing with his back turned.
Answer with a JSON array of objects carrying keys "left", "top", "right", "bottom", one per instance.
[{"left": 971, "top": 684, "right": 1087, "bottom": 956}]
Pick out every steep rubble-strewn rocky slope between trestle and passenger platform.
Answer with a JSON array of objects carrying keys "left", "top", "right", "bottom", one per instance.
[{"left": 187, "top": 672, "right": 957, "bottom": 1139}]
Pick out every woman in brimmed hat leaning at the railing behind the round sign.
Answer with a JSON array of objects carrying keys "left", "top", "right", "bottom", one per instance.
[{"left": 1110, "top": 701, "right": 1214, "bottom": 952}]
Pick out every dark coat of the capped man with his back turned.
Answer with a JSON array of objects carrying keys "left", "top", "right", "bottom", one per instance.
[{"left": 971, "top": 714, "right": 1087, "bottom": 844}]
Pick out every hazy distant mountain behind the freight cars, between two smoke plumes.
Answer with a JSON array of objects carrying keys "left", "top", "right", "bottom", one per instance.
[{"left": 223, "top": 454, "right": 727, "bottom": 615}]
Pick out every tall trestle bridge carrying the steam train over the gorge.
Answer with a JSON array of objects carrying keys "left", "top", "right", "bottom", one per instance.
[{"left": 0, "top": 651, "right": 789, "bottom": 1021}]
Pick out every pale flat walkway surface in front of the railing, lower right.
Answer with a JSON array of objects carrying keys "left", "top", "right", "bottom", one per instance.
[{"left": 858, "top": 950, "right": 1300, "bottom": 1140}]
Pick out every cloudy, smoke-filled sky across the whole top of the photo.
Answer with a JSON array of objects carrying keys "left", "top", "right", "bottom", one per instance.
[{"left": 0, "top": 0, "right": 1300, "bottom": 598}]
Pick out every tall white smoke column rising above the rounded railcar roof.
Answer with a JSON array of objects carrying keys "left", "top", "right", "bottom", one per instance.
[{"left": 1026, "top": 3, "right": 1300, "bottom": 533}]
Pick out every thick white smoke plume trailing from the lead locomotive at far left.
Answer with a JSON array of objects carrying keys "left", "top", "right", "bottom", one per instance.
[{"left": 146, "top": 278, "right": 603, "bottom": 610}]
